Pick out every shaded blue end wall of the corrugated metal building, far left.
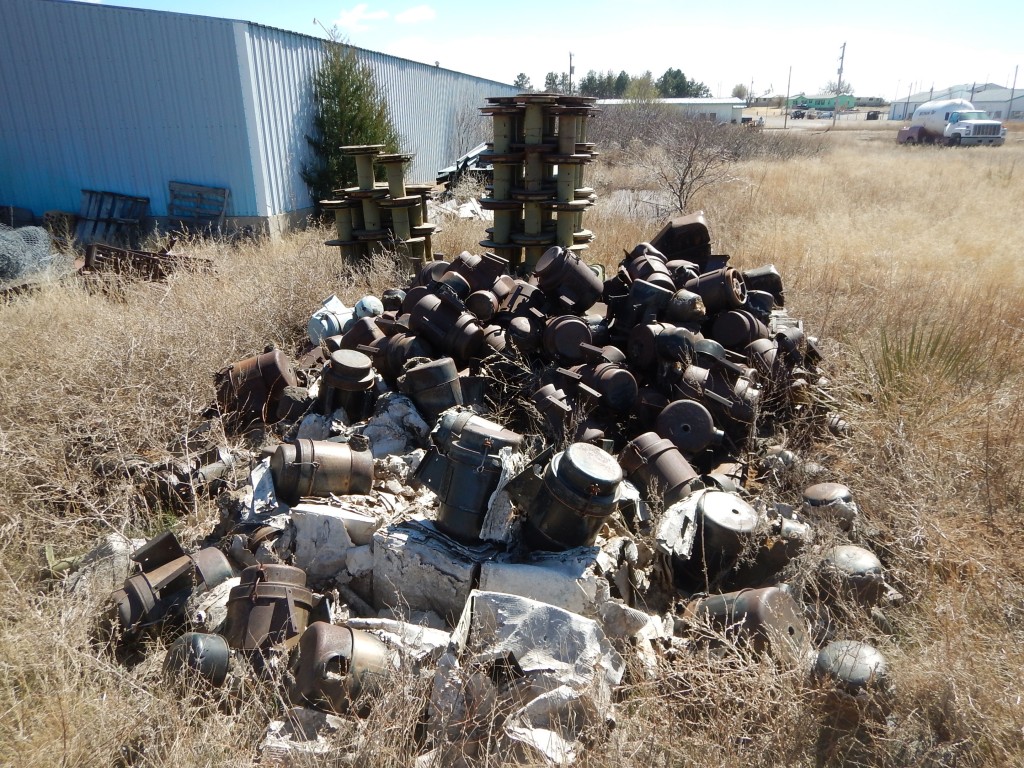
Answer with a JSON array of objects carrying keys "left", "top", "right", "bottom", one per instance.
[{"left": 0, "top": 0, "right": 257, "bottom": 216}]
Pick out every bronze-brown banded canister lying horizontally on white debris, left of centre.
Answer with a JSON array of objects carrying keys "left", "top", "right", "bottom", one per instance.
[{"left": 270, "top": 439, "right": 374, "bottom": 504}]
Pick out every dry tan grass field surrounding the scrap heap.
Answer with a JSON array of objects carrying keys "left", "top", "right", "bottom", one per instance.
[{"left": 0, "top": 135, "right": 1024, "bottom": 768}]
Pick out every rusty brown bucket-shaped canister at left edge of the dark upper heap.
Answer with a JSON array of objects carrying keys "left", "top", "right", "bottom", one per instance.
[{"left": 217, "top": 349, "right": 297, "bottom": 422}]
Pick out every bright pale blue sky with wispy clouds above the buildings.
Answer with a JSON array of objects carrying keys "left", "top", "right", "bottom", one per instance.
[{"left": 75, "top": 0, "right": 1024, "bottom": 99}]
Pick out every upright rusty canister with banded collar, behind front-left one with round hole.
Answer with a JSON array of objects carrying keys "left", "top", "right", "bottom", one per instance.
[{"left": 224, "top": 565, "right": 312, "bottom": 650}]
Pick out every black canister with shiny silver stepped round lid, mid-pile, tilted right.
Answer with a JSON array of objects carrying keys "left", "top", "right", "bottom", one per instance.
[{"left": 523, "top": 442, "right": 623, "bottom": 551}]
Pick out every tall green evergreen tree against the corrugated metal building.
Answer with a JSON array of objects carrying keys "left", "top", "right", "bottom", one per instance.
[{"left": 302, "top": 42, "right": 400, "bottom": 210}]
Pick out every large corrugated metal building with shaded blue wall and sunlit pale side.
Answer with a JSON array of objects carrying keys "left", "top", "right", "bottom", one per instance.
[{"left": 0, "top": 0, "right": 516, "bottom": 230}]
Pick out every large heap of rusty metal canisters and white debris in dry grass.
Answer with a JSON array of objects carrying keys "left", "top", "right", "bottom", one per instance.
[{"left": 77, "top": 214, "right": 899, "bottom": 765}]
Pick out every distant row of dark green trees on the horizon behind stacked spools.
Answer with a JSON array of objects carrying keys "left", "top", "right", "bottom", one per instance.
[{"left": 512, "top": 68, "right": 712, "bottom": 98}]
